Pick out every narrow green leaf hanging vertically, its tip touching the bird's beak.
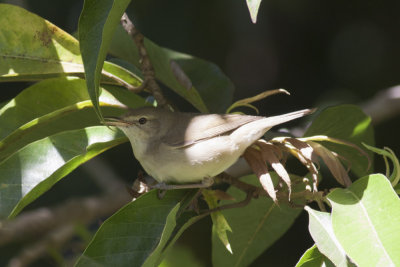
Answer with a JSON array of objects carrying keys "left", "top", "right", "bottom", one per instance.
[{"left": 78, "top": 0, "right": 130, "bottom": 120}]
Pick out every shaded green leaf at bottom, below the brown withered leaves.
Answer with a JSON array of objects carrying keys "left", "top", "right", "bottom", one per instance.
[{"left": 212, "top": 173, "right": 304, "bottom": 266}]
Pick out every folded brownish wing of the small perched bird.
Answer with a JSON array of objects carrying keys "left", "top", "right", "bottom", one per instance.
[{"left": 161, "top": 114, "right": 263, "bottom": 148}]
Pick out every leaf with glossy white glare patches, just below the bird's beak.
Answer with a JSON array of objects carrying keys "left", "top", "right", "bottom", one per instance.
[{"left": 0, "top": 126, "right": 126, "bottom": 218}]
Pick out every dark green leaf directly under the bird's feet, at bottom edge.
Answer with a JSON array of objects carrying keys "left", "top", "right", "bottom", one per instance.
[{"left": 76, "top": 190, "right": 194, "bottom": 266}]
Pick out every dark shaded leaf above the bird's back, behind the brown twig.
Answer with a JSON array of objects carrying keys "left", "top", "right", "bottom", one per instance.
[{"left": 110, "top": 26, "right": 234, "bottom": 113}]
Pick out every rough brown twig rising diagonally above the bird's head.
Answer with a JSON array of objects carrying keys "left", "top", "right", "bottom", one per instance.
[{"left": 121, "top": 13, "right": 167, "bottom": 106}]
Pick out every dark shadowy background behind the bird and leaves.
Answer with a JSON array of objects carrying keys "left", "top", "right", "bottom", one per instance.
[{"left": 0, "top": 0, "right": 400, "bottom": 266}]
